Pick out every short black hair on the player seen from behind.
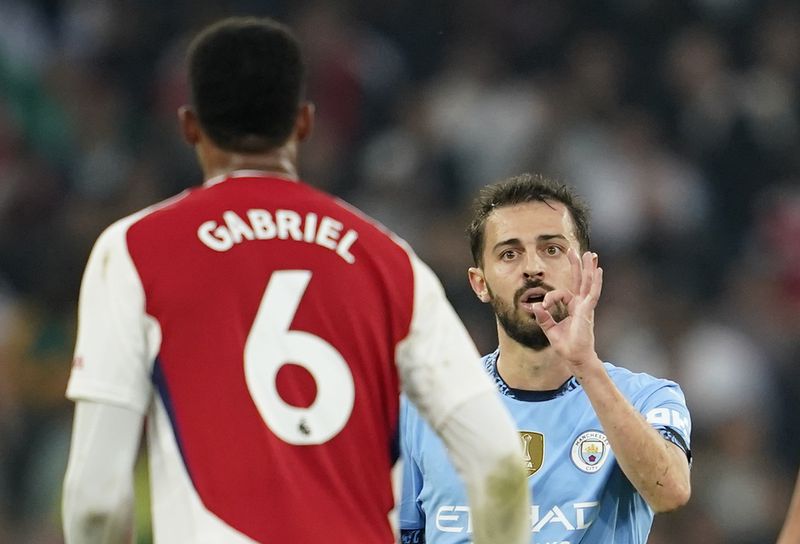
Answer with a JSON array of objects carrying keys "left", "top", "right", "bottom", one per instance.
[{"left": 188, "top": 17, "right": 305, "bottom": 153}]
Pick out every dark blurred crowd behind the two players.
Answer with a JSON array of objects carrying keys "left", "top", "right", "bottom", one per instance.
[{"left": 0, "top": 0, "right": 800, "bottom": 544}]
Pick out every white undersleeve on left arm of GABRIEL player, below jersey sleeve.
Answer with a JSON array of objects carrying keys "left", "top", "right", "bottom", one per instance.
[{"left": 62, "top": 401, "right": 144, "bottom": 544}]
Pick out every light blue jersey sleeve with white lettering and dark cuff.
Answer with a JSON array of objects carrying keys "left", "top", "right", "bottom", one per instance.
[{"left": 641, "top": 380, "right": 692, "bottom": 461}]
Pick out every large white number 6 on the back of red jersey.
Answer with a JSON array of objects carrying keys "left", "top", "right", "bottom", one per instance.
[{"left": 244, "top": 270, "right": 355, "bottom": 446}]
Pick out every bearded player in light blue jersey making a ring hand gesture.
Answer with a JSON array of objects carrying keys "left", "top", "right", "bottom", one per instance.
[{"left": 400, "top": 174, "right": 690, "bottom": 544}]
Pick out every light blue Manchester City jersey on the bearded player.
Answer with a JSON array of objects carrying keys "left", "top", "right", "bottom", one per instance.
[{"left": 400, "top": 351, "right": 691, "bottom": 544}]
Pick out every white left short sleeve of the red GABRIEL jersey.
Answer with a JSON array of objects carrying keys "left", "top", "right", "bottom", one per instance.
[{"left": 67, "top": 217, "right": 160, "bottom": 413}]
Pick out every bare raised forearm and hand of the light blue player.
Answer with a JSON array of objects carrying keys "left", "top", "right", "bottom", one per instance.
[{"left": 534, "top": 250, "right": 691, "bottom": 512}]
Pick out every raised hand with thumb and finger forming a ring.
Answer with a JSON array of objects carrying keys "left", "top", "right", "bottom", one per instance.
[{"left": 533, "top": 249, "right": 603, "bottom": 377}]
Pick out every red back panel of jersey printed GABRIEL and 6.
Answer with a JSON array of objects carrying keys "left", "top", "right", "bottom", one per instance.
[{"left": 127, "top": 176, "right": 414, "bottom": 543}]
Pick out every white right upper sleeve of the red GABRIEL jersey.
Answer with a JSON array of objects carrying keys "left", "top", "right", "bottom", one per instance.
[{"left": 396, "top": 253, "right": 494, "bottom": 430}]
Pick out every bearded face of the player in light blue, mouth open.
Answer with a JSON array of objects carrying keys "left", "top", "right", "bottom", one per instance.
[{"left": 469, "top": 201, "right": 580, "bottom": 350}]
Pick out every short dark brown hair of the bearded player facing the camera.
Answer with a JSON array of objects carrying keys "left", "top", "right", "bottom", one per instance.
[{"left": 467, "top": 174, "right": 589, "bottom": 266}]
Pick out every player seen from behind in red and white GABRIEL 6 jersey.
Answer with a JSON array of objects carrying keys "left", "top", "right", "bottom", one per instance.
[{"left": 63, "top": 18, "right": 530, "bottom": 544}]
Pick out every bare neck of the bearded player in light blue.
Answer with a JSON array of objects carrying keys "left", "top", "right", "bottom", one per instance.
[{"left": 497, "top": 328, "right": 572, "bottom": 391}]
